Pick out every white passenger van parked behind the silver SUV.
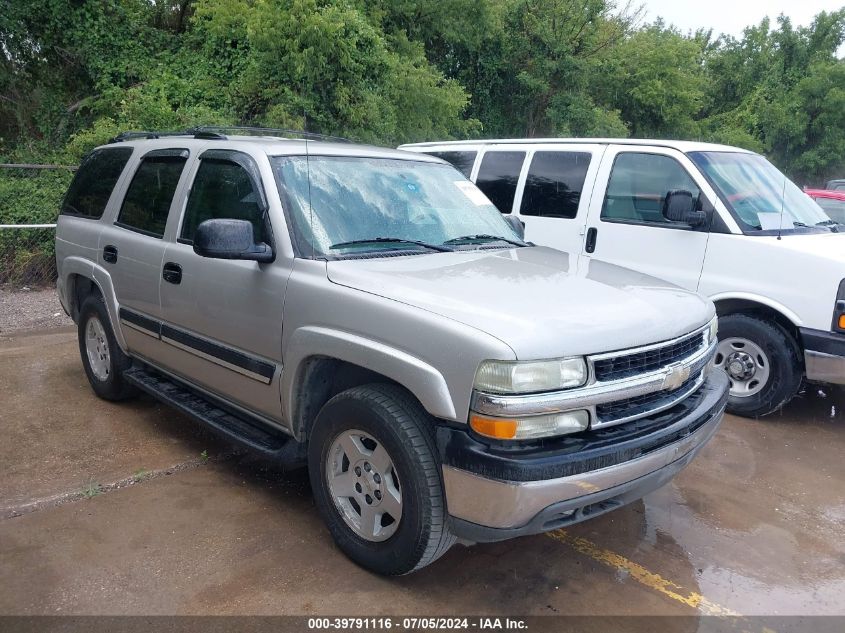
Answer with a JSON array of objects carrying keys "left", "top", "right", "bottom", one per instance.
[{"left": 402, "top": 139, "right": 845, "bottom": 416}]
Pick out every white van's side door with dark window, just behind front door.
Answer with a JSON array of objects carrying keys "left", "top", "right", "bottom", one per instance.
[{"left": 515, "top": 145, "right": 603, "bottom": 259}]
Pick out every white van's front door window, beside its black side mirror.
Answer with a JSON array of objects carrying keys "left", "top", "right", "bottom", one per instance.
[{"left": 601, "top": 152, "right": 701, "bottom": 226}]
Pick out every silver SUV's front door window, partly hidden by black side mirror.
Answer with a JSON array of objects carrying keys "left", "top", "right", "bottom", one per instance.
[{"left": 180, "top": 159, "right": 269, "bottom": 242}]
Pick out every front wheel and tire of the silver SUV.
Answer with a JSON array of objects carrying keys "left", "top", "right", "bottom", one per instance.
[{"left": 308, "top": 384, "right": 455, "bottom": 576}]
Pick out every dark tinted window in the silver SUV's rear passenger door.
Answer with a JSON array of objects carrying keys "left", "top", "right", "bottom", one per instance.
[{"left": 116, "top": 156, "right": 185, "bottom": 237}]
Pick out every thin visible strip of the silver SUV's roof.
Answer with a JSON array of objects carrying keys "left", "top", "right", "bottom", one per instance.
[{"left": 101, "top": 133, "right": 442, "bottom": 163}]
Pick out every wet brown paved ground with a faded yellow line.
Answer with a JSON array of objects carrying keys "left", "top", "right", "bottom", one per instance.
[{"left": 0, "top": 327, "right": 845, "bottom": 630}]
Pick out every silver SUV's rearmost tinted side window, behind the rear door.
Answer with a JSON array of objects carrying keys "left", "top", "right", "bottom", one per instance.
[{"left": 62, "top": 147, "right": 132, "bottom": 220}]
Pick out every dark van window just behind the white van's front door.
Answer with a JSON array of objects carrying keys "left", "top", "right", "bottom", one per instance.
[{"left": 519, "top": 152, "right": 591, "bottom": 218}]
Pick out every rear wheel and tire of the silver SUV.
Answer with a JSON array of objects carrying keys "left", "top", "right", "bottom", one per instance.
[{"left": 78, "top": 295, "right": 138, "bottom": 401}]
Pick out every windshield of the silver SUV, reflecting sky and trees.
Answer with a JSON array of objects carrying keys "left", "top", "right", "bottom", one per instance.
[{"left": 272, "top": 156, "right": 524, "bottom": 257}]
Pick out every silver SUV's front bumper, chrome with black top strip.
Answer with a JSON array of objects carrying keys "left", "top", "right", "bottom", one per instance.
[{"left": 437, "top": 370, "right": 728, "bottom": 542}]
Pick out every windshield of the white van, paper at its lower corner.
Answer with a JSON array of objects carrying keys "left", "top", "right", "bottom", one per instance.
[{"left": 689, "top": 152, "right": 829, "bottom": 231}]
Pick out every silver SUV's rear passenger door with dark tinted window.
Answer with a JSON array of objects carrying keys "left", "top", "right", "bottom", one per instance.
[{"left": 99, "top": 148, "right": 189, "bottom": 360}]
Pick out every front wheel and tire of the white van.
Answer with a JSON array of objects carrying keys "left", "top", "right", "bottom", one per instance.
[{"left": 714, "top": 314, "right": 804, "bottom": 418}]
